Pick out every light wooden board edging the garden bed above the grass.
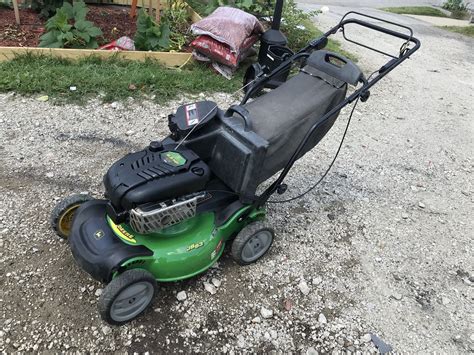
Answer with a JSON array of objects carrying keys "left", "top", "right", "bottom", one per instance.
[{"left": 0, "top": 47, "right": 191, "bottom": 67}]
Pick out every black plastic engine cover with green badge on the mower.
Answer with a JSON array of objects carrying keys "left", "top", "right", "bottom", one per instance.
[{"left": 104, "top": 142, "right": 210, "bottom": 219}]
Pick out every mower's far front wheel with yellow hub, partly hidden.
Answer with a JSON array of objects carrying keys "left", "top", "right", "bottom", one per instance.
[{"left": 50, "top": 194, "right": 93, "bottom": 239}]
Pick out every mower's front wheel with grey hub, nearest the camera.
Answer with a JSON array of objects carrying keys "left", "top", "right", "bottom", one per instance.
[{"left": 98, "top": 269, "right": 158, "bottom": 325}]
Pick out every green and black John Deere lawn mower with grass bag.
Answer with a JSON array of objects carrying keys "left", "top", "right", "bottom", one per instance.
[{"left": 51, "top": 12, "right": 420, "bottom": 325}]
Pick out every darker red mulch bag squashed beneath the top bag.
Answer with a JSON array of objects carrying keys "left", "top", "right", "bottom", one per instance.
[{"left": 190, "top": 35, "right": 258, "bottom": 68}]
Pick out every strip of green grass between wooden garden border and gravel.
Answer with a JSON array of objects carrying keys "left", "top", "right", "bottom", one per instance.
[{"left": 0, "top": 54, "right": 244, "bottom": 103}]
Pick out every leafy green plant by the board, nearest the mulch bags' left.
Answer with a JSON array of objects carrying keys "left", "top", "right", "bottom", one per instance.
[{"left": 134, "top": 9, "right": 171, "bottom": 51}]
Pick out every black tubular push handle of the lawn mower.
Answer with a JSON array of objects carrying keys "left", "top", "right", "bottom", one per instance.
[{"left": 241, "top": 11, "right": 421, "bottom": 207}]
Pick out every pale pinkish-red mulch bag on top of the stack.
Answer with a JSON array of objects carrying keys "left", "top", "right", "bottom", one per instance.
[{"left": 191, "top": 7, "right": 263, "bottom": 54}]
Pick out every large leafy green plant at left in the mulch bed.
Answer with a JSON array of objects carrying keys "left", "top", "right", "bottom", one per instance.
[{"left": 39, "top": 1, "right": 102, "bottom": 48}]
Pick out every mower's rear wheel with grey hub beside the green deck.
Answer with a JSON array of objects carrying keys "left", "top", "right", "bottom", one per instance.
[{"left": 231, "top": 221, "right": 275, "bottom": 265}]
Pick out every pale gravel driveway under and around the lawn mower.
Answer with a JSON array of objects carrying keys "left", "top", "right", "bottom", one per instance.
[{"left": 0, "top": 6, "right": 474, "bottom": 353}]
